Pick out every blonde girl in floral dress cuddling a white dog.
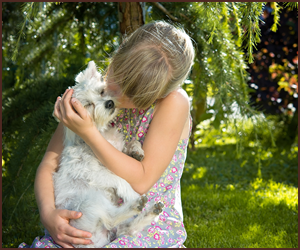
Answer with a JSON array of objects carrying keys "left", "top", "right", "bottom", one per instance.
[{"left": 20, "top": 21, "right": 194, "bottom": 248}]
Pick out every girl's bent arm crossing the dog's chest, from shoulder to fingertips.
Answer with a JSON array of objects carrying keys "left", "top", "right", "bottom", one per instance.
[{"left": 54, "top": 89, "right": 189, "bottom": 194}]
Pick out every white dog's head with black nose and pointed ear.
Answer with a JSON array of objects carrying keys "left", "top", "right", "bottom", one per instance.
[{"left": 72, "top": 61, "right": 118, "bottom": 129}]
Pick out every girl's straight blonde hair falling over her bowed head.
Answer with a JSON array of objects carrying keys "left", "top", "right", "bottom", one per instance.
[{"left": 106, "top": 21, "right": 195, "bottom": 108}]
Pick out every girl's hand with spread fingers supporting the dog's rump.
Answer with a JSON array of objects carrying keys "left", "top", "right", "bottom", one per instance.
[{"left": 41, "top": 209, "right": 93, "bottom": 248}]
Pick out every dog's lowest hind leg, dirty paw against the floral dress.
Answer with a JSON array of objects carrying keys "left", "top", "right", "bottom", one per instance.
[{"left": 117, "top": 199, "right": 164, "bottom": 237}]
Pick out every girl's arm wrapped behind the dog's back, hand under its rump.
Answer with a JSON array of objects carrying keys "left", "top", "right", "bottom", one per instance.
[{"left": 34, "top": 114, "right": 91, "bottom": 248}]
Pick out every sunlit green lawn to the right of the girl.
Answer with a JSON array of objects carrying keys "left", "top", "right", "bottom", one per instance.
[{"left": 181, "top": 145, "right": 298, "bottom": 248}]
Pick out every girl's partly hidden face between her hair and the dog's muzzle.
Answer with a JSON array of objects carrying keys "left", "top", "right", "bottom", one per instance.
[{"left": 106, "top": 71, "right": 136, "bottom": 108}]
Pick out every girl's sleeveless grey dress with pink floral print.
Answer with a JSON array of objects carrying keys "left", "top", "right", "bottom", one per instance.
[{"left": 19, "top": 101, "right": 192, "bottom": 248}]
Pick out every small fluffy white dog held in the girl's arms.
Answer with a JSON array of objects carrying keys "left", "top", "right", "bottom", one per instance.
[{"left": 53, "top": 61, "right": 163, "bottom": 248}]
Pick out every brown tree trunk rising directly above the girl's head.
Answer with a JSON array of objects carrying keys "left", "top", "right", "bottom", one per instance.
[{"left": 118, "top": 2, "right": 145, "bottom": 35}]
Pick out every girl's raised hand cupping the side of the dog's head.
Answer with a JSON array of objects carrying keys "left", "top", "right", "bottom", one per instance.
[{"left": 54, "top": 89, "right": 96, "bottom": 139}]
